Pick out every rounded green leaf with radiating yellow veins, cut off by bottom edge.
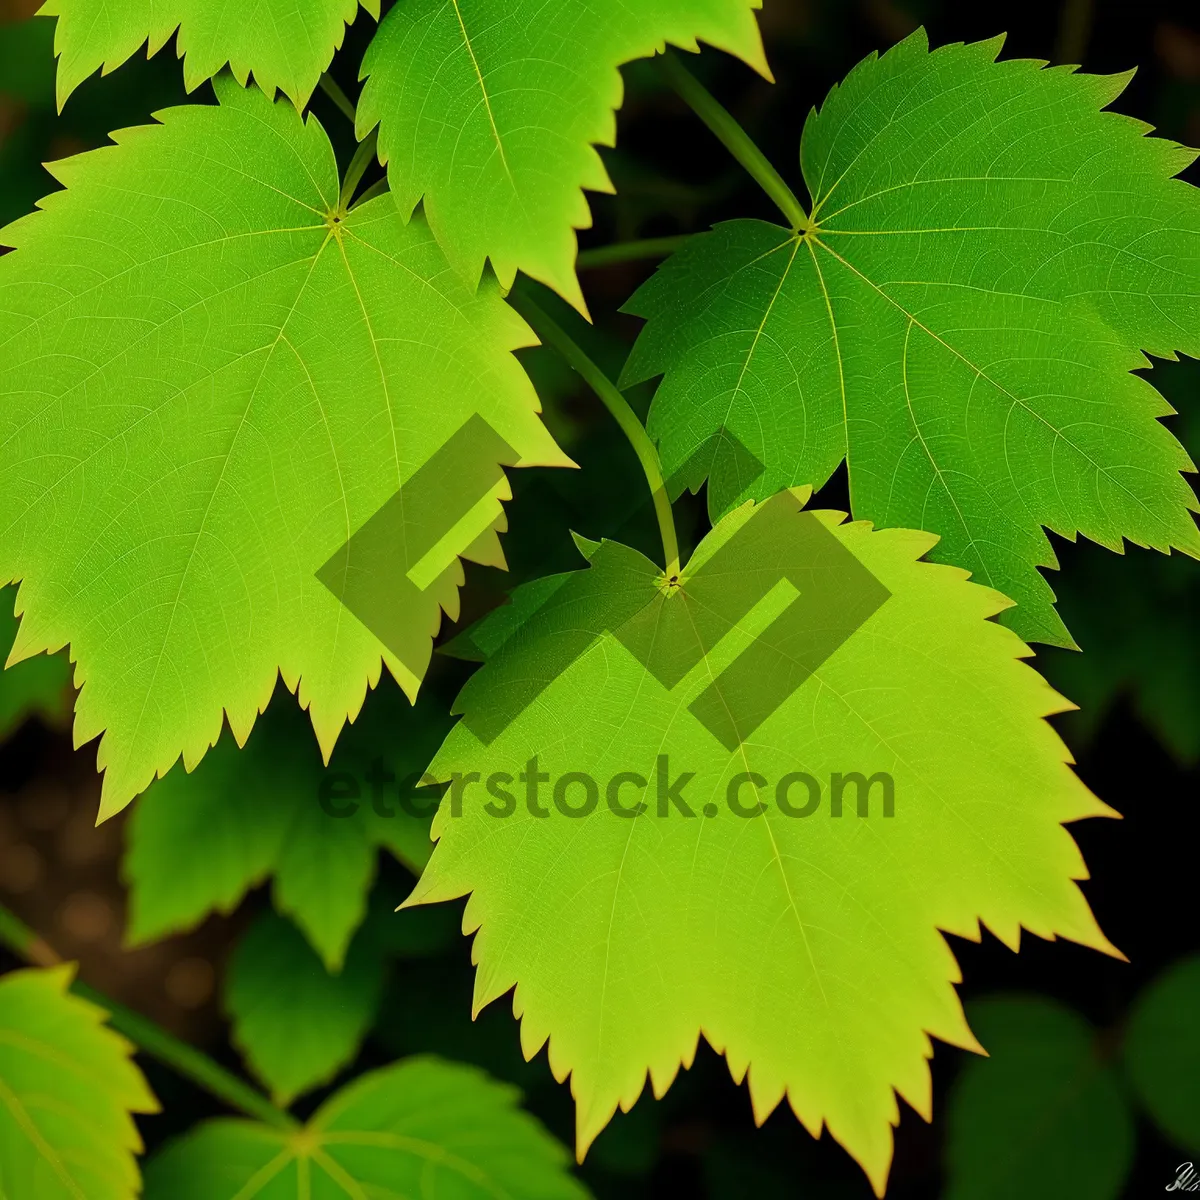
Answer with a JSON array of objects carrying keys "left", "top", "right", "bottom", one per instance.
[{"left": 146, "top": 1058, "right": 587, "bottom": 1200}]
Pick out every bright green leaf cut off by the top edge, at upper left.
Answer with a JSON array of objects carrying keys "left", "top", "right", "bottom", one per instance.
[{"left": 41, "top": 0, "right": 379, "bottom": 108}]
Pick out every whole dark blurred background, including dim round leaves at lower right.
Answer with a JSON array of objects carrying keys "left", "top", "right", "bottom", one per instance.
[{"left": 0, "top": 0, "right": 1200, "bottom": 1200}]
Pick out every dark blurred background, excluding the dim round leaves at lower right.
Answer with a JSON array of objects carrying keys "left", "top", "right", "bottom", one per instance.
[{"left": 0, "top": 0, "right": 1200, "bottom": 1200}]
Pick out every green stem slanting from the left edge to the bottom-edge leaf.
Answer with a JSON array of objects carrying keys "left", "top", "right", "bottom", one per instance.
[{"left": 0, "top": 905, "right": 300, "bottom": 1132}]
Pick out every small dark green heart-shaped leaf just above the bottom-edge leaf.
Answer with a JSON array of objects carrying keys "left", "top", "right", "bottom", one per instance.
[{"left": 226, "top": 912, "right": 384, "bottom": 1108}]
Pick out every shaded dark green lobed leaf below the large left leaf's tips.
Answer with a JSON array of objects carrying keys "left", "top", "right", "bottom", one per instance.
[{"left": 122, "top": 685, "right": 450, "bottom": 971}]
